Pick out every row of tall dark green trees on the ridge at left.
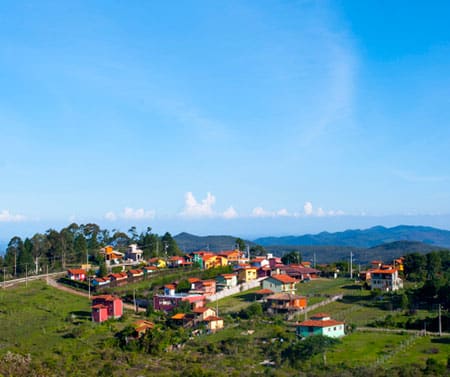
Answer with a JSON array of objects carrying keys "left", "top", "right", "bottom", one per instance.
[{"left": 0, "top": 223, "right": 182, "bottom": 279}]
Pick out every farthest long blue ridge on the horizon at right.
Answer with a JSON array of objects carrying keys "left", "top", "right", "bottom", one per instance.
[{"left": 254, "top": 225, "right": 450, "bottom": 248}]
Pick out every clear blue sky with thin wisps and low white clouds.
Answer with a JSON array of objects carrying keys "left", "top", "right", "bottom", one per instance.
[{"left": 0, "top": 0, "right": 450, "bottom": 239}]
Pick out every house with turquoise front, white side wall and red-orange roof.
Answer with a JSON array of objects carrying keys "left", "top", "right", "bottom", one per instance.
[{"left": 296, "top": 313, "right": 345, "bottom": 338}]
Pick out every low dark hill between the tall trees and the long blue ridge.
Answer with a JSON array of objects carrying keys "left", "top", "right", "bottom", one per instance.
[{"left": 174, "top": 233, "right": 254, "bottom": 253}]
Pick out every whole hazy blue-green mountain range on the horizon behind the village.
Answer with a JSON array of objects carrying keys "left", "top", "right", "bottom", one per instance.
[{"left": 174, "top": 225, "right": 450, "bottom": 264}]
